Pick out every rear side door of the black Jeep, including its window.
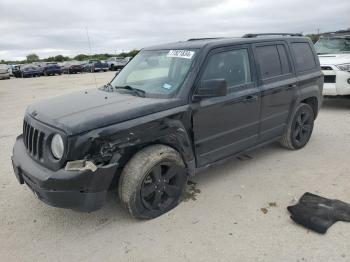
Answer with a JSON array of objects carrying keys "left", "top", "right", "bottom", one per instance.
[{"left": 254, "top": 41, "right": 298, "bottom": 143}]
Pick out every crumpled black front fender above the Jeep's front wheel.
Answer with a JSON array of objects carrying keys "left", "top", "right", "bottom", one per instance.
[{"left": 69, "top": 106, "right": 195, "bottom": 174}]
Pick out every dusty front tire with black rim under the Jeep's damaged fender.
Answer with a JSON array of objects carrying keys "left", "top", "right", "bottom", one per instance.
[{"left": 118, "top": 145, "right": 187, "bottom": 219}]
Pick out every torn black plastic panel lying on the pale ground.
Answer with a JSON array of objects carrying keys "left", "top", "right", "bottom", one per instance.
[{"left": 287, "top": 192, "right": 350, "bottom": 234}]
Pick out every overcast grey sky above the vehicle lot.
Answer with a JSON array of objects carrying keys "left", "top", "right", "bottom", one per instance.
[{"left": 0, "top": 0, "right": 350, "bottom": 60}]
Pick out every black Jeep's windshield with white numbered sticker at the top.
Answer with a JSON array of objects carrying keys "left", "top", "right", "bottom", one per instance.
[{"left": 111, "top": 50, "right": 195, "bottom": 97}]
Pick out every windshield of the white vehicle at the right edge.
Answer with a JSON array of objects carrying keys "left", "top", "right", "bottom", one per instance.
[{"left": 315, "top": 38, "right": 350, "bottom": 54}]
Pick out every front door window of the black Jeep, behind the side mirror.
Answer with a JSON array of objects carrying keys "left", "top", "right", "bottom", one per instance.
[{"left": 202, "top": 49, "right": 252, "bottom": 87}]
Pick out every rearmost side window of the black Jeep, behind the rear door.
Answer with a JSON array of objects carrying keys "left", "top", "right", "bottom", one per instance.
[{"left": 292, "top": 42, "right": 316, "bottom": 72}]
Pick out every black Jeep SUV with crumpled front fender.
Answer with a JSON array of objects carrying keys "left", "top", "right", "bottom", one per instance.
[{"left": 12, "top": 34, "right": 323, "bottom": 218}]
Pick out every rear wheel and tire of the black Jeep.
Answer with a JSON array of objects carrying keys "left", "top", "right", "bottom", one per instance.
[{"left": 280, "top": 103, "right": 315, "bottom": 150}]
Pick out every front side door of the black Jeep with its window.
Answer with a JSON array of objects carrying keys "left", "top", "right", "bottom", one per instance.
[{"left": 192, "top": 45, "right": 260, "bottom": 166}]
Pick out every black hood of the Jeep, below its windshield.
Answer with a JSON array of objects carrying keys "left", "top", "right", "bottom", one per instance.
[{"left": 27, "top": 89, "right": 180, "bottom": 135}]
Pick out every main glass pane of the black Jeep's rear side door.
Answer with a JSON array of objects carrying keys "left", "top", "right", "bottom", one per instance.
[{"left": 256, "top": 45, "right": 283, "bottom": 79}]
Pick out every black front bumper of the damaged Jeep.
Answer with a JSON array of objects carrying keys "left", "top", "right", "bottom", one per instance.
[{"left": 12, "top": 135, "right": 118, "bottom": 212}]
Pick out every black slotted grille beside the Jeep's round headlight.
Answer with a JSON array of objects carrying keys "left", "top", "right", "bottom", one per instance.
[{"left": 23, "top": 121, "right": 45, "bottom": 160}]
